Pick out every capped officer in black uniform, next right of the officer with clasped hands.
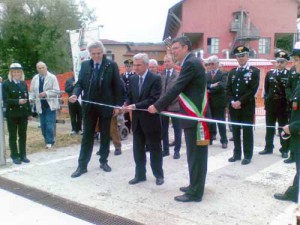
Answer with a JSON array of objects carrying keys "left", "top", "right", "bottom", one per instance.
[{"left": 259, "top": 51, "right": 290, "bottom": 158}]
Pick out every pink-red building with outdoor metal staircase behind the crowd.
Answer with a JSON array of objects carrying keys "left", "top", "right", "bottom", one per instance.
[{"left": 163, "top": 0, "right": 300, "bottom": 59}]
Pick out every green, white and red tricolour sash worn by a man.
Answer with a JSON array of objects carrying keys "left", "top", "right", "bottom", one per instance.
[{"left": 178, "top": 91, "right": 210, "bottom": 146}]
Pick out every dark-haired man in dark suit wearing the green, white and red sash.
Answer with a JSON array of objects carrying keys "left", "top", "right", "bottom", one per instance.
[{"left": 148, "top": 36, "right": 209, "bottom": 202}]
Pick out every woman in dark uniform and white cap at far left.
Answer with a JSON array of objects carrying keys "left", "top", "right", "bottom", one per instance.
[{"left": 3, "top": 63, "right": 32, "bottom": 164}]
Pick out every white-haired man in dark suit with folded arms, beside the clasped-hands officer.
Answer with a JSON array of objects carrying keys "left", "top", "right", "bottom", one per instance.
[{"left": 206, "top": 55, "right": 228, "bottom": 149}]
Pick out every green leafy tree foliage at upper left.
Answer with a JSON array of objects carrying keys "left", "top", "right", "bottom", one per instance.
[{"left": 0, "top": 0, "right": 80, "bottom": 79}]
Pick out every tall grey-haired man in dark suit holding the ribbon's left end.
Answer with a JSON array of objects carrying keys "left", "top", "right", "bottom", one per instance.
[{"left": 69, "top": 41, "right": 122, "bottom": 178}]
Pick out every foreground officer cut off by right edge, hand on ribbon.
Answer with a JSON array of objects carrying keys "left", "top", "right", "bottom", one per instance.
[{"left": 274, "top": 42, "right": 300, "bottom": 202}]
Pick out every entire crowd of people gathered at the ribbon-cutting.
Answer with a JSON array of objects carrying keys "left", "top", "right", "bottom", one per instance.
[{"left": 3, "top": 36, "right": 300, "bottom": 202}]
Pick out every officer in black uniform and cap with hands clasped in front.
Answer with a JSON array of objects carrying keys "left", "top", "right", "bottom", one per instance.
[{"left": 226, "top": 45, "right": 260, "bottom": 165}]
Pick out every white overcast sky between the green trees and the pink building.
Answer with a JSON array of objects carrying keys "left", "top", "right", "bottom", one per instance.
[{"left": 82, "top": 0, "right": 180, "bottom": 42}]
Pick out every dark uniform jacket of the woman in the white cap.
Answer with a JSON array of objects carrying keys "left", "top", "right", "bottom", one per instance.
[{"left": 3, "top": 80, "right": 31, "bottom": 118}]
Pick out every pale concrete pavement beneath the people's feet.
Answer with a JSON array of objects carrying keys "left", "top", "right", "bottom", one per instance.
[{"left": 0, "top": 117, "right": 297, "bottom": 225}]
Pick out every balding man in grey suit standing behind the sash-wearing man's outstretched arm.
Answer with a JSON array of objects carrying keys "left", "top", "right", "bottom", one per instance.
[{"left": 161, "top": 55, "right": 182, "bottom": 159}]
